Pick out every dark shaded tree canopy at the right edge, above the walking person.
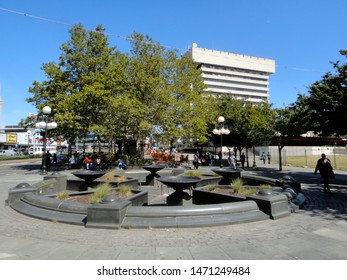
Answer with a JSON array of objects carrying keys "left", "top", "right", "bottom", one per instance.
[{"left": 276, "top": 50, "right": 347, "bottom": 137}]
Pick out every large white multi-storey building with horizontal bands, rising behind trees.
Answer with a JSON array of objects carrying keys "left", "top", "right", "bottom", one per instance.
[{"left": 188, "top": 43, "right": 275, "bottom": 103}]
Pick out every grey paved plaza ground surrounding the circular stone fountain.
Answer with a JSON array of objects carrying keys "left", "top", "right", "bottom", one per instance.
[{"left": 0, "top": 159, "right": 347, "bottom": 260}]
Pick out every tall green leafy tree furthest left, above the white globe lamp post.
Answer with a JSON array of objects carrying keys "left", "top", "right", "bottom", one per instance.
[{"left": 27, "top": 25, "right": 120, "bottom": 152}]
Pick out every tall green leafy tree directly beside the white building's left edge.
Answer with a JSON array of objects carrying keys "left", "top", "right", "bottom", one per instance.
[{"left": 122, "top": 33, "right": 215, "bottom": 154}]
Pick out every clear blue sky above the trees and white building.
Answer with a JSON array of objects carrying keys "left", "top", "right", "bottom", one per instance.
[{"left": 0, "top": 0, "right": 347, "bottom": 127}]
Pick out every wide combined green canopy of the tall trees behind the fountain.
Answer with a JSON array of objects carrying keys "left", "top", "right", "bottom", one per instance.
[{"left": 27, "top": 25, "right": 211, "bottom": 155}]
